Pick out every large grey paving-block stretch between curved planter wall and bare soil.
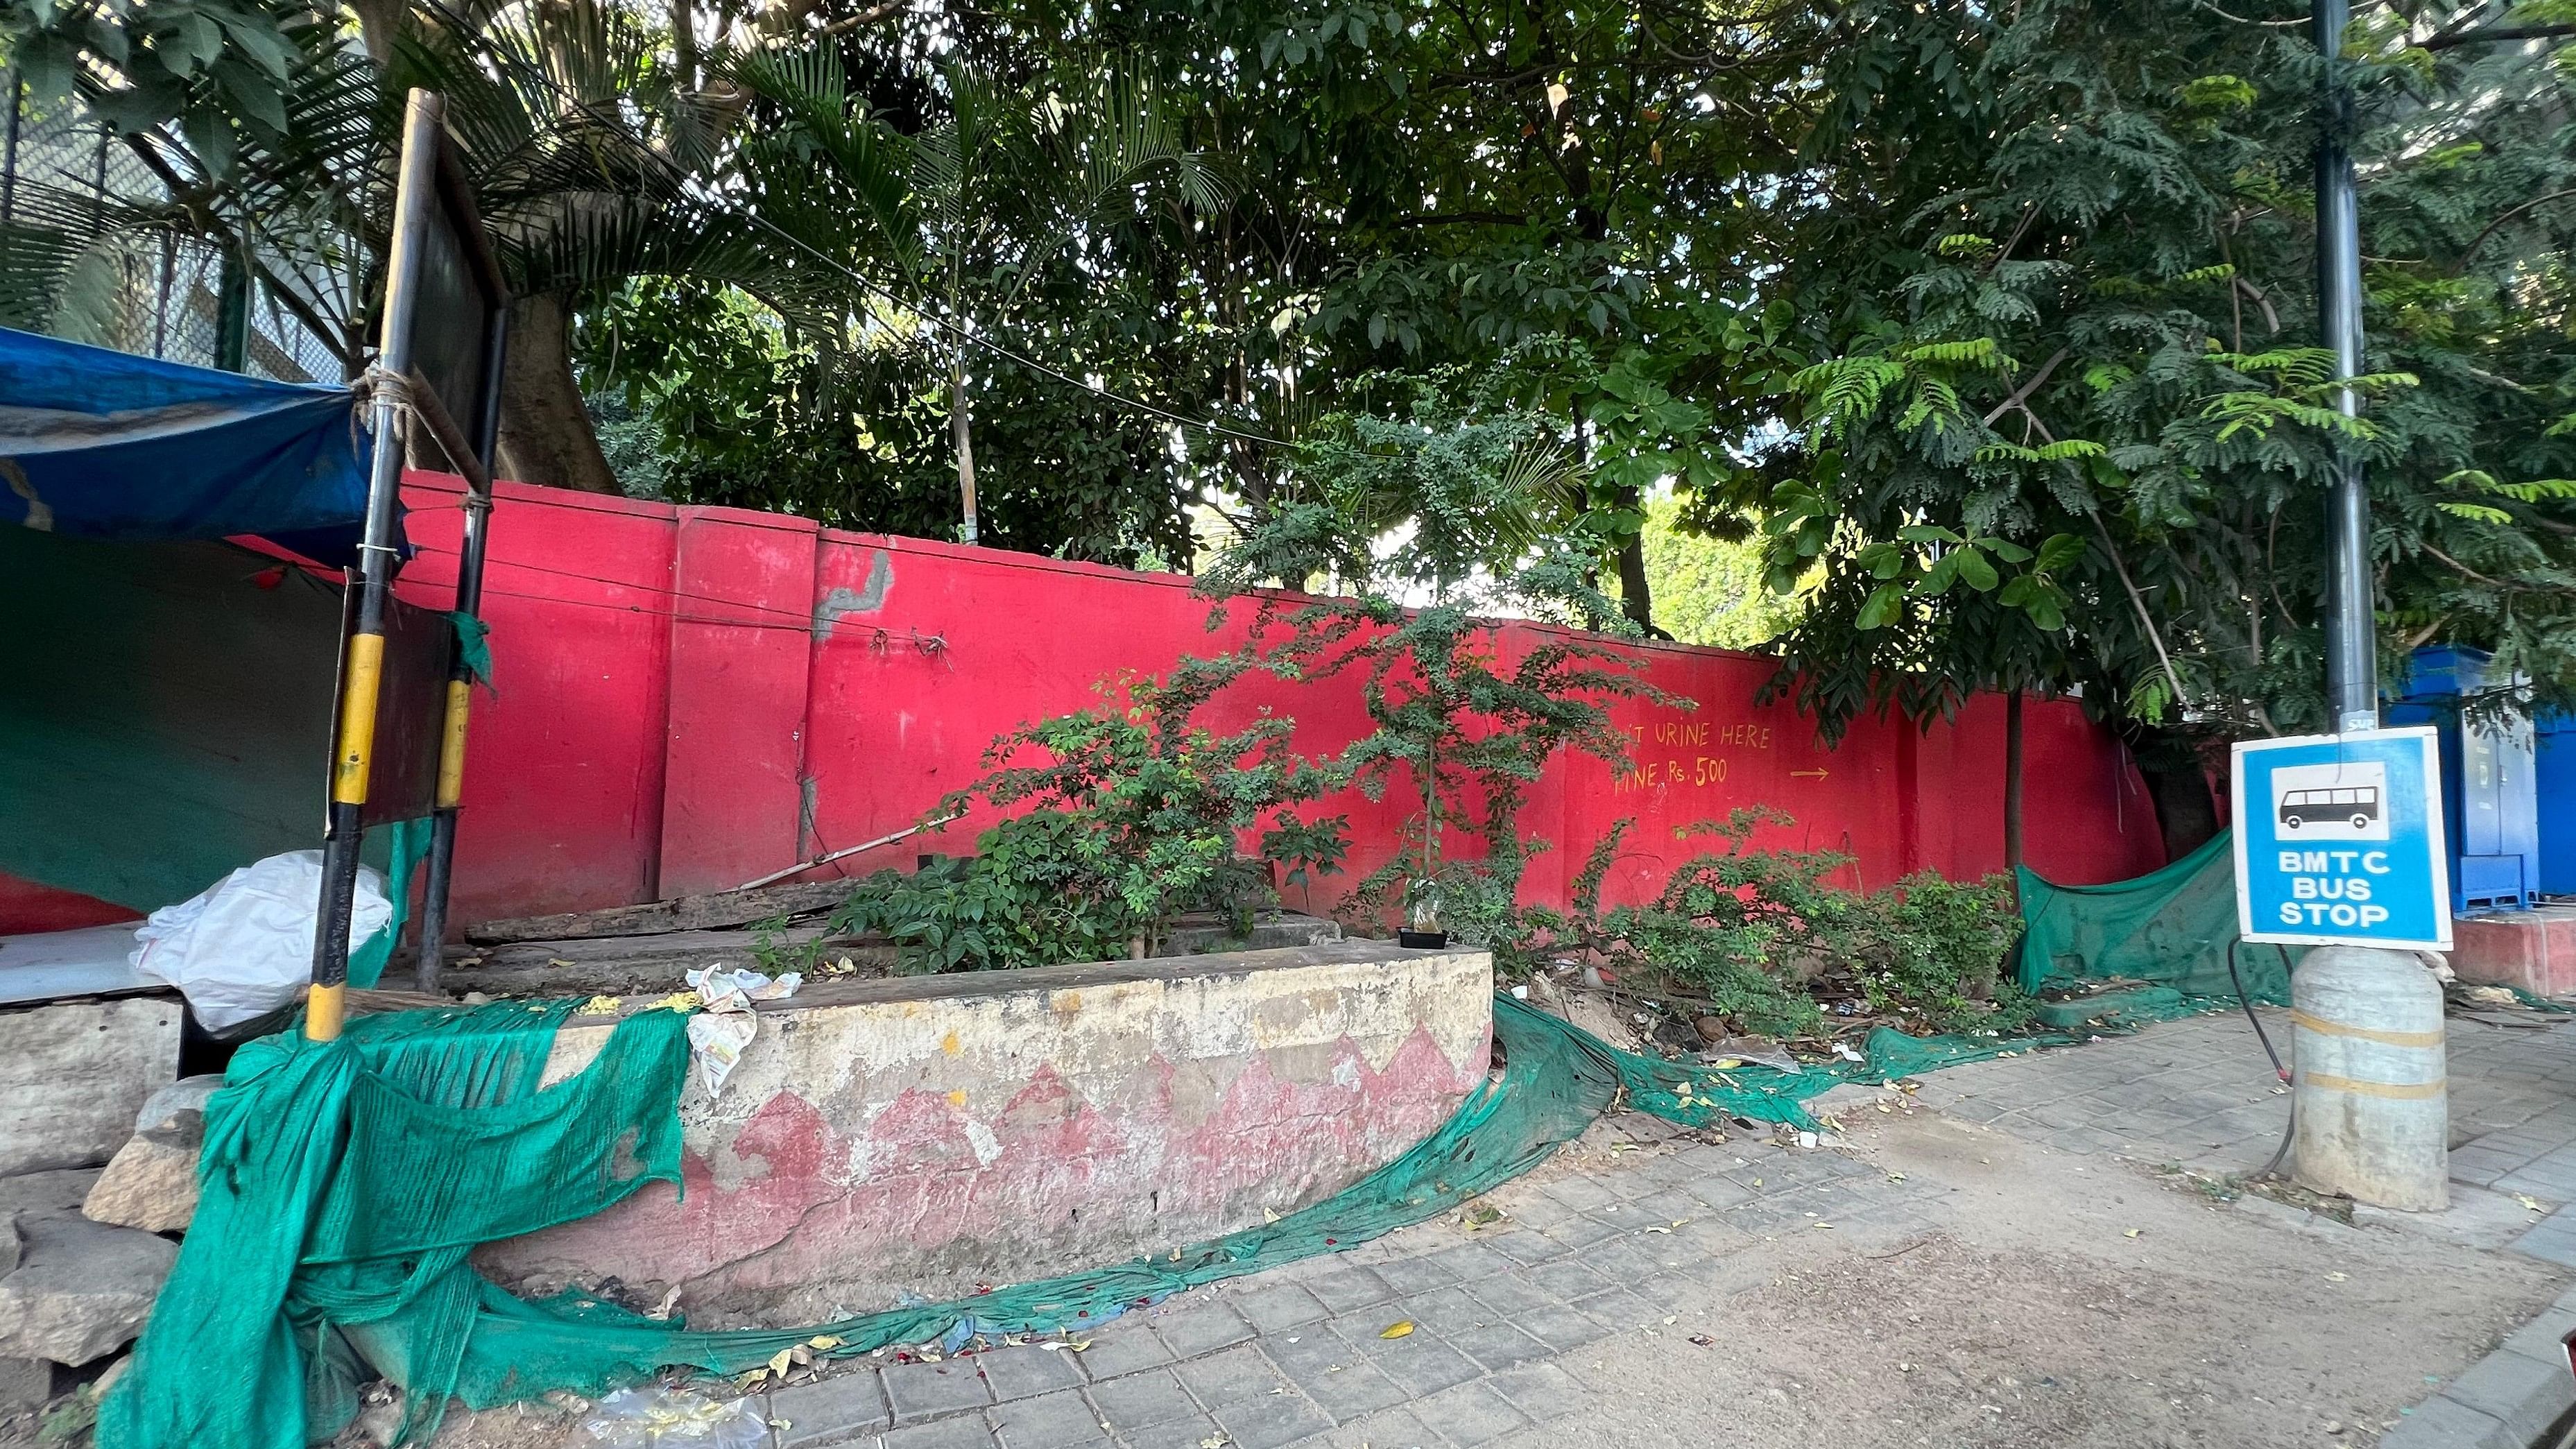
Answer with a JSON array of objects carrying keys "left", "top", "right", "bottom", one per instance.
[{"left": 770, "top": 1140, "right": 1930, "bottom": 1449}]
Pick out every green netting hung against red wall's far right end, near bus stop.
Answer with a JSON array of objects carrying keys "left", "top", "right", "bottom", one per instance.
[{"left": 2020, "top": 833, "right": 2290, "bottom": 1016}]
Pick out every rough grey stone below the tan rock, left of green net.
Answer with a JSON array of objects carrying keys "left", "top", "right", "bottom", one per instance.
[{"left": 0, "top": 1212, "right": 178, "bottom": 1364}]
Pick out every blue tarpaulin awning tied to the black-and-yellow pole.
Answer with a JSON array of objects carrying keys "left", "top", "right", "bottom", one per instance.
[{"left": 0, "top": 327, "right": 381, "bottom": 562}]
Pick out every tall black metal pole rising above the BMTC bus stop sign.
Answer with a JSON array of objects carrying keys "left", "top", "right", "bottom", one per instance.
[{"left": 2316, "top": 0, "right": 2380, "bottom": 732}]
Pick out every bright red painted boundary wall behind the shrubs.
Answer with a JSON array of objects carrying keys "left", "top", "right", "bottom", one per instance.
[{"left": 376, "top": 474, "right": 2164, "bottom": 920}]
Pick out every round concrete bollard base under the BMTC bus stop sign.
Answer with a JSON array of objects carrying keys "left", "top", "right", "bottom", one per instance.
[{"left": 2290, "top": 946, "right": 2450, "bottom": 1212}]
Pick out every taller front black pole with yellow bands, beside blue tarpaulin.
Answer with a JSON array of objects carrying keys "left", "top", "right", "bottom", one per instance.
[{"left": 304, "top": 90, "right": 440, "bottom": 1042}]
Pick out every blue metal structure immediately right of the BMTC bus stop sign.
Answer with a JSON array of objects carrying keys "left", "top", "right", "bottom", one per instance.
[{"left": 2385, "top": 644, "right": 2543, "bottom": 916}]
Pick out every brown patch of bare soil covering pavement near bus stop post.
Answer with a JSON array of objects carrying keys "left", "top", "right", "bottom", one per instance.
[{"left": 1548, "top": 1098, "right": 2563, "bottom": 1449}]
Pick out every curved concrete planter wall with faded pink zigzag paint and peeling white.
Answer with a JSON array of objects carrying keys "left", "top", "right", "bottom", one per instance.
[{"left": 479, "top": 941, "right": 1494, "bottom": 1326}]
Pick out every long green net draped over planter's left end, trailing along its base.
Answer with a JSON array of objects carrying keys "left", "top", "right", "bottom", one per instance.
[{"left": 98, "top": 995, "right": 1875, "bottom": 1449}]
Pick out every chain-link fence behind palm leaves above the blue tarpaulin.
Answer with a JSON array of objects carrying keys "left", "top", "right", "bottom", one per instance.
[{"left": 0, "top": 69, "right": 347, "bottom": 381}]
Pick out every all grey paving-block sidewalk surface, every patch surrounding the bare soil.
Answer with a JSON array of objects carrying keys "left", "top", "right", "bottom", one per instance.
[{"left": 737, "top": 1013, "right": 2576, "bottom": 1449}]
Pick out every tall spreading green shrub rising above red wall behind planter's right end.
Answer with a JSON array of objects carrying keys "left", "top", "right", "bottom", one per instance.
[{"left": 1203, "top": 379, "right": 1690, "bottom": 949}]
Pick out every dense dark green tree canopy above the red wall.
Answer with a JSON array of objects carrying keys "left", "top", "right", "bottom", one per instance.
[{"left": 0, "top": 0, "right": 2576, "bottom": 799}]
